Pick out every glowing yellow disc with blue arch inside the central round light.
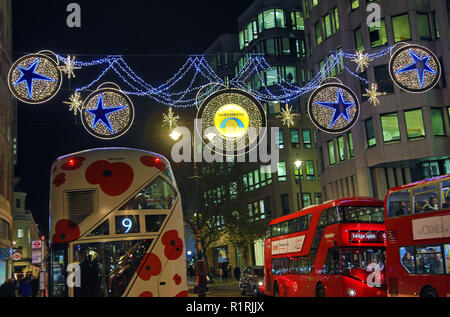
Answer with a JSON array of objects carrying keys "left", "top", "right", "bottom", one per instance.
[{"left": 214, "top": 104, "right": 249, "bottom": 138}]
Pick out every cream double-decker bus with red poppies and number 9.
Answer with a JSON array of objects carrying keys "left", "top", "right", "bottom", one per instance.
[{"left": 49, "top": 148, "right": 188, "bottom": 297}]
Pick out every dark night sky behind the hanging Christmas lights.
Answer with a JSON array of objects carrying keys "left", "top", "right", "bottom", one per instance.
[{"left": 12, "top": 0, "right": 252, "bottom": 232}]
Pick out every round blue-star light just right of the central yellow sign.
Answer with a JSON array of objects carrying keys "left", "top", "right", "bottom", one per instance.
[{"left": 308, "top": 83, "right": 360, "bottom": 133}]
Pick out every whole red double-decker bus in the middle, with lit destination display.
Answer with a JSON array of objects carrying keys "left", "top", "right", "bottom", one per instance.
[{"left": 264, "top": 197, "right": 386, "bottom": 297}]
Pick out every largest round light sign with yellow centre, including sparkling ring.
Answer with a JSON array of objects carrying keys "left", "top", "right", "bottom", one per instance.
[{"left": 197, "top": 88, "right": 267, "bottom": 155}]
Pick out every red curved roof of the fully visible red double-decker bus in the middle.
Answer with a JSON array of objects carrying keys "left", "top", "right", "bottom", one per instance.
[{"left": 269, "top": 197, "right": 384, "bottom": 226}]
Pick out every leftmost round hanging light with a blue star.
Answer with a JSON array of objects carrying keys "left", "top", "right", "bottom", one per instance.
[{"left": 8, "top": 53, "right": 62, "bottom": 104}]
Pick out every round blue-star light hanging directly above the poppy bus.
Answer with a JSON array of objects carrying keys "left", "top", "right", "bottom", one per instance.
[{"left": 81, "top": 84, "right": 134, "bottom": 139}]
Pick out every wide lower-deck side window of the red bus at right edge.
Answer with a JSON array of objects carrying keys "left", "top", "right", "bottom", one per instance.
[{"left": 416, "top": 246, "right": 444, "bottom": 274}]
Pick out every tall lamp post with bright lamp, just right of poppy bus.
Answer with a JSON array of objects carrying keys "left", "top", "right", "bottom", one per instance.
[{"left": 169, "top": 130, "right": 207, "bottom": 297}]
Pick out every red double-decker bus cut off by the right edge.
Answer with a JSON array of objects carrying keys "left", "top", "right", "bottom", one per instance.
[{"left": 385, "top": 174, "right": 450, "bottom": 297}]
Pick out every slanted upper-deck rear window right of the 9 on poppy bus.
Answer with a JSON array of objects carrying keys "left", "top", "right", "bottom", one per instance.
[{"left": 119, "top": 177, "right": 177, "bottom": 210}]
